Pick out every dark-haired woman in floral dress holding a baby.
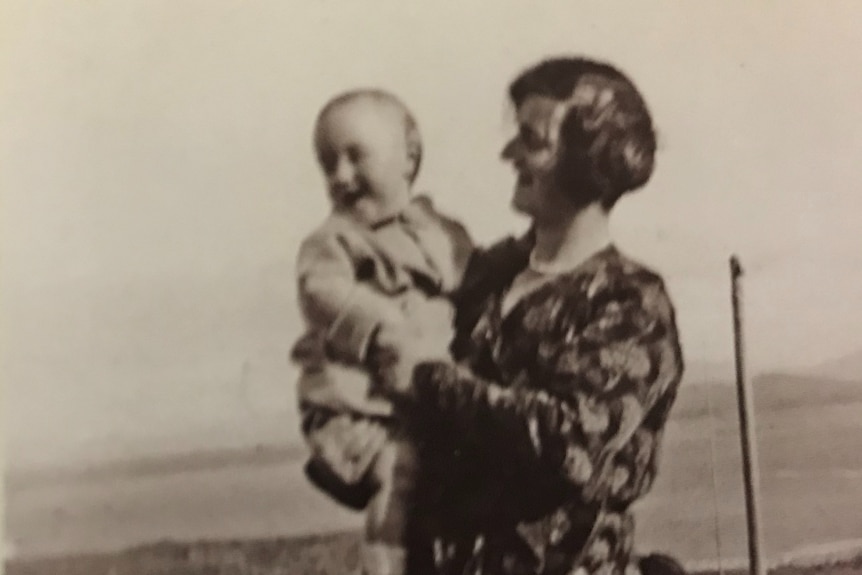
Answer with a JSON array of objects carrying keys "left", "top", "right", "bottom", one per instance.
[{"left": 372, "top": 58, "right": 683, "bottom": 575}]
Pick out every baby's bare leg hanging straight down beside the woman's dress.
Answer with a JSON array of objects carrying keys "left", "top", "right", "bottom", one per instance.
[{"left": 362, "top": 434, "right": 416, "bottom": 575}]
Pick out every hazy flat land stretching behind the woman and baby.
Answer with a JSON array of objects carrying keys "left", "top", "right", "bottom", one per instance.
[{"left": 7, "top": 376, "right": 862, "bottom": 575}]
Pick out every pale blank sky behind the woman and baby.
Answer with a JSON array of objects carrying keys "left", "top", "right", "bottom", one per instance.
[{"left": 0, "top": 0, "right": 862, "bottom": 468}]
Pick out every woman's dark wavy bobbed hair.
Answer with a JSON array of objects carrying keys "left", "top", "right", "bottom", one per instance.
[{"left": 509, "top": 57, "right": 656, "bottom": 210}]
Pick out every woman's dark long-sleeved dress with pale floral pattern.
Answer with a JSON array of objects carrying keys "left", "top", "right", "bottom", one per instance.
[{"left": 408, "top": 238, "right": 683, "bottom": 575}]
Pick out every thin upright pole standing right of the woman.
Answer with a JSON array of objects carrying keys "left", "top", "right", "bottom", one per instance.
[{"left": 730, "top": 256, "right": 766, "bottom": 575}]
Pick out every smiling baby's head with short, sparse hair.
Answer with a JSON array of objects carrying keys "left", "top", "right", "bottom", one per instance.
[{"left": 314, "top": 89, "right": 422, "bottom": 224}]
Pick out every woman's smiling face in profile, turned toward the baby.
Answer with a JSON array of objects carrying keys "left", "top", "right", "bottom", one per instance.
[{"left": 502, "top": 96, "right": 574, "bottom": 221}]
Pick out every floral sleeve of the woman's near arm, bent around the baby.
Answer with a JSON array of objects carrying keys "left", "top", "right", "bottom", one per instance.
[{"left": 414, "top": 276, "right": 682, "bottom": 494}]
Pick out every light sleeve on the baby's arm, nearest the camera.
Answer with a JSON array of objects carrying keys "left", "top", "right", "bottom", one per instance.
[{"left": 297, "top": 233, "right": 403, "bottom": 365}]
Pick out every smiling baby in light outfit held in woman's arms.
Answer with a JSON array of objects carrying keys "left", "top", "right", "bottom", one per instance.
[{"left": 292, "top": 90, "right": 473, "bottom": 575}]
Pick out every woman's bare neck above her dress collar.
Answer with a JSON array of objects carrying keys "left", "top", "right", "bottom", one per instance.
[{"left": 533, "top": 203, "right": 611, "bottom": 268}]
